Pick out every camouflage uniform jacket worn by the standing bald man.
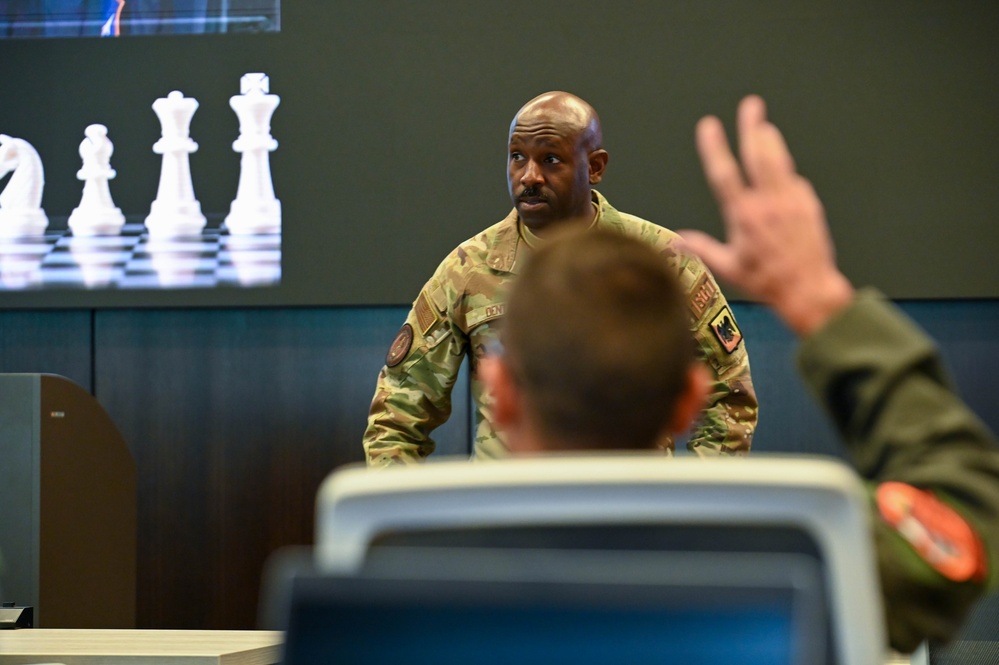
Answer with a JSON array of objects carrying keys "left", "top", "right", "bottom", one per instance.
[{"left": 364, "top": 192, "right": 757, "bottom": 466}]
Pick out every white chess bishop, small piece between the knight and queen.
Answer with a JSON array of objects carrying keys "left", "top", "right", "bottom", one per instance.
[{"left": 69, "top": 124, "right": 125, "bottom": 236}]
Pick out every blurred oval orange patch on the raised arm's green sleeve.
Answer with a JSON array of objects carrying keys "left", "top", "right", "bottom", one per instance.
[{"left": 876, "top": 482, "right": 986, "bottom": 582}]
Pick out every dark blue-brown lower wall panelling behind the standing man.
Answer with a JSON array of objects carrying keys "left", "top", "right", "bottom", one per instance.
[{"left": 0, "top": 300, "right": 999, "bottom": 629}]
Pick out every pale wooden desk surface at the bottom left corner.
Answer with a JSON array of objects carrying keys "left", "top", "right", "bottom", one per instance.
[{"left": 0, "top": 628, "right": 283, "bottom": 665}]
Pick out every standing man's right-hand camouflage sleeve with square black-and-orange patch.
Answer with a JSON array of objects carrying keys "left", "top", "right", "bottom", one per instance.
[{"left": 680, "top": 257, "right": 758, "bottom": 457}]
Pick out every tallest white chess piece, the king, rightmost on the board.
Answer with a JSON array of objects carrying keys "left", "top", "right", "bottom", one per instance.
[{"left": 225, "top": 73, "right": 281, "bottom": 235}]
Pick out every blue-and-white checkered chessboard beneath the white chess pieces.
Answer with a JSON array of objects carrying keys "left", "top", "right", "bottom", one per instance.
[{"left": 0, "top": 221, "right": 281, "bottom": 291}]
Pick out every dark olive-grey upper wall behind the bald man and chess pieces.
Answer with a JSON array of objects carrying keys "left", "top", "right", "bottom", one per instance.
[{"left": 0, "top": 0, "right": 999, "bottom": 307}]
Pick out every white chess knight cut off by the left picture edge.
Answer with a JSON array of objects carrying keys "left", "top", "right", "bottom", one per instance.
[{"left": 0, "top": 134, "right": 49, "bottom": 238}]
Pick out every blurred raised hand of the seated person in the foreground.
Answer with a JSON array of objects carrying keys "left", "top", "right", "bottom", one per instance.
[{"left": 681, "top": 96, "right": 853, "bottom": 335}]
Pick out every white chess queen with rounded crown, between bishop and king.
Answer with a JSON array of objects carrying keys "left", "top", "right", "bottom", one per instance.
[{"left": 146, "top": 90, "right": 206, "bottom": 238}]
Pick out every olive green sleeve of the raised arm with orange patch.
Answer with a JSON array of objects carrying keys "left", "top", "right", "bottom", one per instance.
[{"left": 798, "top": 290, "right": 999, "bottom": 653}]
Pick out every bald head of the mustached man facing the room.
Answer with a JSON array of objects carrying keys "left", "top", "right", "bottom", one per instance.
[{"left": 507, "top": 92, "right": 607, "bottom": 233}]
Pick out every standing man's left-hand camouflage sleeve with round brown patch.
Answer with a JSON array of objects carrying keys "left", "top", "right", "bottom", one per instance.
[{"left": 363, "top": 276, "right": 467, "bottom": 467}]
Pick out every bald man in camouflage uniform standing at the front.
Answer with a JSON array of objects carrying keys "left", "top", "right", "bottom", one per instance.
[{"left": 364, "top": 92, "right": 757, "bottom": 466}]
